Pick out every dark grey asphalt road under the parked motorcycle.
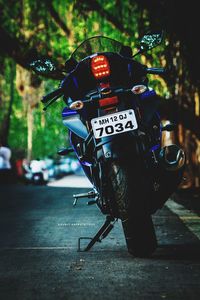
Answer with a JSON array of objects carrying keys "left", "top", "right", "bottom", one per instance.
[{"left": 0, "top": 178, "right": 200, "bottom": 300}]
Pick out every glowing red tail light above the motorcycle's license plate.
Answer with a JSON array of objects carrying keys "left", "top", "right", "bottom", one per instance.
[{"left": 91, "top": 55, "right": 110, "bottom": 79}]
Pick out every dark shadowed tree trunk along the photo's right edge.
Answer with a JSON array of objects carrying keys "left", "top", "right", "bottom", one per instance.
[{"left": 135, "top": 0, "right": 200, "bottom": 186}]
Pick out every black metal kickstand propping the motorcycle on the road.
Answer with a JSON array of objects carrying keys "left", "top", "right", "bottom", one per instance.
[{"left": 78, "top": 216, "right": 117, "bottom": 252}]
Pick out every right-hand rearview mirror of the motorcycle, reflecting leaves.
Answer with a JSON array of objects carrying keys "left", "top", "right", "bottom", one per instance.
[{"left": 140, "top": 32, "right": 163, "bottom": 52}]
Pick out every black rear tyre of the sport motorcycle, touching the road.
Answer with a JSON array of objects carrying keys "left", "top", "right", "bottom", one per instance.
[{"left": 109, "top": 162, "right": 157, "bottom": 257}]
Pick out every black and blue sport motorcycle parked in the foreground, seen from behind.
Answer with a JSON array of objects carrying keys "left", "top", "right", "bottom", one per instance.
[{"left": 30, "top": 33, "right": 186, "bottom": 257}]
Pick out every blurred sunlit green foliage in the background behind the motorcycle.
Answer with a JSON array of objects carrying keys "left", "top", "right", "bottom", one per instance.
[{"left": 0, "top": 0, "right": 182, "bottom": 157}]
